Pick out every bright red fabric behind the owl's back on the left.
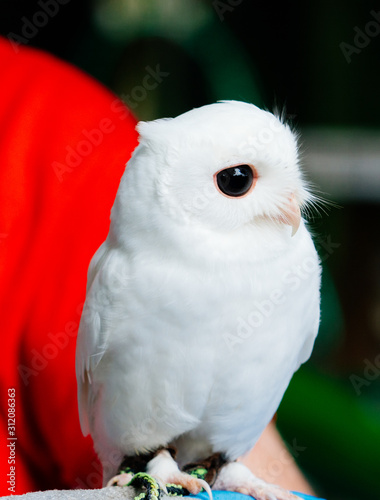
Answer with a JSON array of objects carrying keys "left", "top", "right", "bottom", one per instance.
[{"left": 0, "top": 40, "right": 137, "bottom": 495}]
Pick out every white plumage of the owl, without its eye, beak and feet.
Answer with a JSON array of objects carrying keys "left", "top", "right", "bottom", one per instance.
[{"left": 76, "top": 101, "right": 320, "bottom": 479}]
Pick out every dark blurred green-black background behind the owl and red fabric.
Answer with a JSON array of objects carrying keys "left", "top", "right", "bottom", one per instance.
[{"left": 0, "top": 0, "right": 380, "bottom": 500}]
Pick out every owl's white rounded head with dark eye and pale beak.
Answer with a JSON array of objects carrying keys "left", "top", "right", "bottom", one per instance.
[{"left": 118, "top": 101, "right": 312, "bottom": 233}]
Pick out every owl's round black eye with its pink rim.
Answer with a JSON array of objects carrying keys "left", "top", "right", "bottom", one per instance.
[{"left": 214, "top": 163, "right": 257, "bottom": 198}]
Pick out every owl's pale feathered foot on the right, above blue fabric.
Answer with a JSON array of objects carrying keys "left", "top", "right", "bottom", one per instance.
[{"left": 213, "top": 462, "right": 300, "bottom": 500}]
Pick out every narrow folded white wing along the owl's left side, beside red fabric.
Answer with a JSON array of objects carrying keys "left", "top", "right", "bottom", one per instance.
[{"left": 75, "top": 243, "right": 118, "bottom": 436}]
